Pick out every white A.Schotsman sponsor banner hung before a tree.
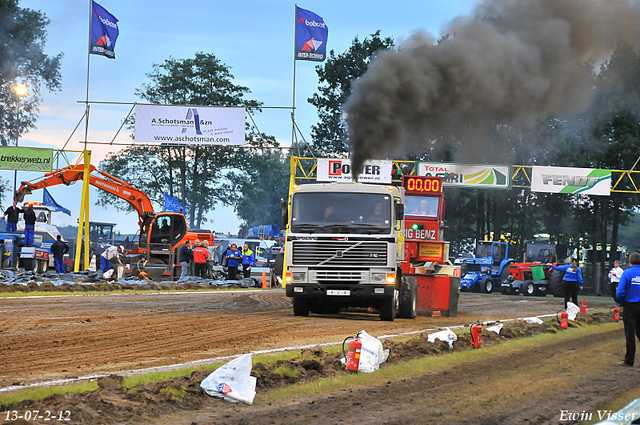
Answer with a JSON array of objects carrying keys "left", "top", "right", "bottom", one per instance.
[{"left": 135, "top": 105, "right": 245, "bottom": 146}]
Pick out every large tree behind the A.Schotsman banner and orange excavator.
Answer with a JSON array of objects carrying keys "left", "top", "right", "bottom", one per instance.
[{"left": 98, "top": 53, "right": 275, "bottom": 228}]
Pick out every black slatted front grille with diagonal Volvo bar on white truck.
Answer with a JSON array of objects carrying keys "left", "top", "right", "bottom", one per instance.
[{"left": 293, "top": 241, "right": 387, "bottom": 267}]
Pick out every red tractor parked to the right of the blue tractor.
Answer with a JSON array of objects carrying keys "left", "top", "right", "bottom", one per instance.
[{"left": 500, "top": 242, "right": 563, "bottom": 297}]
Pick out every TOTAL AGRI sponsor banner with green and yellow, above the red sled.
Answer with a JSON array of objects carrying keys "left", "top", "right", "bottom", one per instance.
[{"left": 416, "top": 162, "right": 511, "bottom": 189}]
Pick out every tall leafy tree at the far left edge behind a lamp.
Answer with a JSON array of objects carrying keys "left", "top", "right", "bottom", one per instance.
[{"left": 0, "top": 0, "right": 62, "bottom": 146}]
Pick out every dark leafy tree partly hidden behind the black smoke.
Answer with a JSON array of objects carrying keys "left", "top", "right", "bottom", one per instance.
[{"left": 308, "top": 30, "right": 394, "bottom": 156}]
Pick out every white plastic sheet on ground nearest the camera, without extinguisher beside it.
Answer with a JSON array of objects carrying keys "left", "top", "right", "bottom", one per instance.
[{"left": 200, "top": 354, "right": 256, "bottom": 404}]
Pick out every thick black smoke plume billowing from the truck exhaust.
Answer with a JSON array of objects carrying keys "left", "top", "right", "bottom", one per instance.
[{"left": 344, "top": 0, "right": 640, "bottom": 170}]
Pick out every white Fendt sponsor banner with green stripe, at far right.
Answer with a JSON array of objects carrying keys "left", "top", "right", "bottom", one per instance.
[{"left": 531, "top": 166, "right": 611, "bottom": 196}]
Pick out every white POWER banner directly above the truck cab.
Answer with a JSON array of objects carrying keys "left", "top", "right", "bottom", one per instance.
[{"left": 316, "top": 158, "right": 393, "bottom": 183}]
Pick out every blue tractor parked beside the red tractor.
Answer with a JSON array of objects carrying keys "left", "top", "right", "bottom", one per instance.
[{"left": 460, "top": 241, "right": 515, "bottom": 294}]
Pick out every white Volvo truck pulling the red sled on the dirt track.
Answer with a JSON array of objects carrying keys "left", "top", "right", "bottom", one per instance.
[{"left": 284, "top": 182, "right": 417, "bottom": 321}]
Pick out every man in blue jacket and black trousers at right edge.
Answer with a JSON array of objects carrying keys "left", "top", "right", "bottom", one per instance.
[{"left": 616, "top": 252, "right": 640, "bottom": 366}]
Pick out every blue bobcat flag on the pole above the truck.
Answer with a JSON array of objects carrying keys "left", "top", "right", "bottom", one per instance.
[{"left": 296, "top": 6, "right": 329, "bottom": 62}]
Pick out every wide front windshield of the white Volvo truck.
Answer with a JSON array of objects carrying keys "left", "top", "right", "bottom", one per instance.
[{"left": 291, "top": 192, "right": 391, "bottom": 234}]
